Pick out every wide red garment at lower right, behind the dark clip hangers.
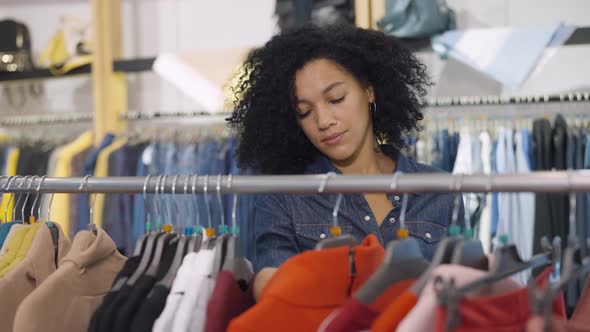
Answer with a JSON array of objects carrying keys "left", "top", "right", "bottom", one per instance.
[{"left": 436, "top": 268, "right": 566, "bottom": 332}]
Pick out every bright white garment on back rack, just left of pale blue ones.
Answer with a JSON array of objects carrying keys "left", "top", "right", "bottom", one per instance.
[{"left": 478, "top": 131, "right": 492, "bottom": 254}]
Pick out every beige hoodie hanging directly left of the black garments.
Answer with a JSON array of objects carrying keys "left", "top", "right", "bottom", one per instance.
[{"left": 14, "top": 228, "right": 127, "bottom": 332}]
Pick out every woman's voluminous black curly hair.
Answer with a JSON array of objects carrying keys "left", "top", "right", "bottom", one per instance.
[{"left": 228, "top": 25, "right": 431, "bottom": 174}]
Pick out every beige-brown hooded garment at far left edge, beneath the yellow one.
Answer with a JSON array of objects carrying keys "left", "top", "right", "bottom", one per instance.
[{"left": 0, "top": 225, "right": 70, "bottom": 332}]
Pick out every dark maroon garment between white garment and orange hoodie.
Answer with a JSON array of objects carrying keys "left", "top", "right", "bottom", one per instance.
[{"left": 205, "top": 271, "right": 255, "bottom": 332}]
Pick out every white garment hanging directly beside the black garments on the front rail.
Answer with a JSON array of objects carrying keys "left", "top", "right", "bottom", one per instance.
[{"left": 152, "top": 252, "right": 197, "bottom": 332}]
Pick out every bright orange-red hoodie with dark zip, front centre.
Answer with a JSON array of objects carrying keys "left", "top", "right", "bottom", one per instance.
[{"left": 228, "top": 235, "right": 384, "bottom": 332}]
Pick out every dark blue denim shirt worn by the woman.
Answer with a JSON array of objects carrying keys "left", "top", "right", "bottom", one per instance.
[{"left": 254, "top": 146, "right": 464, "bottom": 271}]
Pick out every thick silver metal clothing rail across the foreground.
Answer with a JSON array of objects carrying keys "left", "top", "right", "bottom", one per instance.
[{"left": 0, "top": 170, "right": 590, "bottom": 194}]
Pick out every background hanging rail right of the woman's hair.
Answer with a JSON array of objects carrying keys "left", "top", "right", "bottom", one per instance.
[{"left": 426, "top": 91, "right": 590, "bottom": 107}]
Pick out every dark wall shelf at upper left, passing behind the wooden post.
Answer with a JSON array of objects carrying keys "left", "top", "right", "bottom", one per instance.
[{"left": 0, "top": 58, "right": 156, "bottom": 82}]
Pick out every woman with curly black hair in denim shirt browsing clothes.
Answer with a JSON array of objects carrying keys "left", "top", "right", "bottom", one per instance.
[{"left": 229, "top": 26, "right": 463, "bottom": 298}]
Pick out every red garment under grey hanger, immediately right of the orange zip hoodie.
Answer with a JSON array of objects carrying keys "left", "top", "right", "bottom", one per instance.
[{"left": 320, "top": 279, "right": 415, "bottom": 332}]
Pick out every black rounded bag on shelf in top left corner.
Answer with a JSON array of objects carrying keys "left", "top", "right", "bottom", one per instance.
[{"left": 0, "top": 19, "right": 33, "bottom": 72}]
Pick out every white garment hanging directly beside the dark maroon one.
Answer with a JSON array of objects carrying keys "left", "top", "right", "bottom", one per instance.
[{"left": 170, "top": 249, "right": 215, "bottom": 332}]
